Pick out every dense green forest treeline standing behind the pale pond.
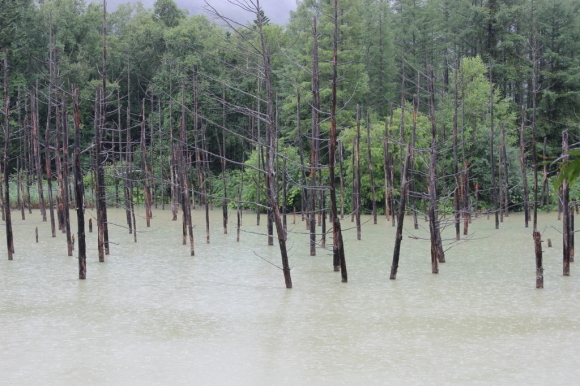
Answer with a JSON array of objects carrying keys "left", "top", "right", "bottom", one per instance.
[{"left": 0, "top": 0, "right": 580, "bottom": 284}]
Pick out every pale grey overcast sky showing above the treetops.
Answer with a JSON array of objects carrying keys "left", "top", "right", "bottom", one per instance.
[{"left": 101, "top": 0, "right": 296, "bottom": 24}]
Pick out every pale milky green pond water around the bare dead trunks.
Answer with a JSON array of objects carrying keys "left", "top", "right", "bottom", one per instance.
[{"left": 0, "top": 209, "right": 580, "bottom": 385}]
